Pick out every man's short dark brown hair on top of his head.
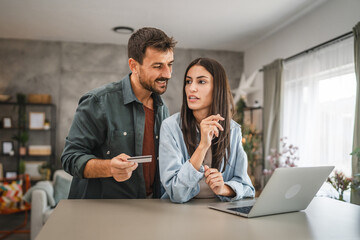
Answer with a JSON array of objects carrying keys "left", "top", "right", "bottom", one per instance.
[{"left": 128, "top": 27, "right": 177, "bottom": 64}]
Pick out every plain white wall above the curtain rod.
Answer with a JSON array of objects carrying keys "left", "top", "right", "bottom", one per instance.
[{"left": 244, "top": 0, "right": 360, "bottom": 105}]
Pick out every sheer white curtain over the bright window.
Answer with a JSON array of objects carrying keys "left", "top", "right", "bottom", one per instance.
[{"left": 280, "top": 37, "right": 356, "bottom": 180}]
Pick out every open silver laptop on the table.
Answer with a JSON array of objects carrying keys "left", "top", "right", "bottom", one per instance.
[{"left": 208, "top": 166, "right": 334, "bottom": 218}]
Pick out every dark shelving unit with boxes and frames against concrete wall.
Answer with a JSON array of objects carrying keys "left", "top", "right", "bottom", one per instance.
[{"left": 0, "top": 102, "right": 56, "bottom": 180}]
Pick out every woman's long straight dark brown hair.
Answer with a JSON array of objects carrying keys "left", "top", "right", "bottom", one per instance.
[{"left": 181, "top": 58, "right": 234, "bottom": 171}]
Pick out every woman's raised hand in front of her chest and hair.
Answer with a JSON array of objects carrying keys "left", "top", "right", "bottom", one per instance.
[{"left": 199, "top": 114, "right": 224, "bottom": 149}]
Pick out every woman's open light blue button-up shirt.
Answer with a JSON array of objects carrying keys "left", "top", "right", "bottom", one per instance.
[{"left": 159, "top": 113, "right": 255, "bottom": 203}]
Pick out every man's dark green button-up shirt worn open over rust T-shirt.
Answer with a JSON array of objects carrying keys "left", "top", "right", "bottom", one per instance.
[{"left": 61, "top": 74, "right": 169, "bottom": 198}]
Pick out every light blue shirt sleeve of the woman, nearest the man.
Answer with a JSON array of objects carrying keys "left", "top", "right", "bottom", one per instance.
[{"left": 159, "top": 120, "right": 204, "bottom": 203}]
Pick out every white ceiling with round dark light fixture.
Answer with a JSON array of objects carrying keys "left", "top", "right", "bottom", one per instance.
[{"left": 0, "top": 0, "right": 327, "bottom": 51}]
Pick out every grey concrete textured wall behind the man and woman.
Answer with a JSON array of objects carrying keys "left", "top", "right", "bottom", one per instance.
[{"left": 0, "top": 39, "right": 244, "bottom": 166}]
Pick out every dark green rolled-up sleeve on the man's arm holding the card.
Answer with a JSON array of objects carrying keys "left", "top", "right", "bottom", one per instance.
[{"left": 61, "top": 94, "right": 106, "bottom": 178}]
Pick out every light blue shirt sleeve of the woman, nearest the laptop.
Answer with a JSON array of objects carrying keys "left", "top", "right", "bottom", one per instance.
[{"left": 218, "top": 127, "right": 255, "bottom": 201}]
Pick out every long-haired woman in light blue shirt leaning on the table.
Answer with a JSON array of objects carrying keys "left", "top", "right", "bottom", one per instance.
[{"left": 159, "top": 58, "right": 255, "bottom": 203}]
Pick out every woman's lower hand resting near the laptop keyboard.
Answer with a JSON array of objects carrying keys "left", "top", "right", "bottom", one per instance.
[{"left": 204, "top": 165, "right": 235, "bottom": 197}]
